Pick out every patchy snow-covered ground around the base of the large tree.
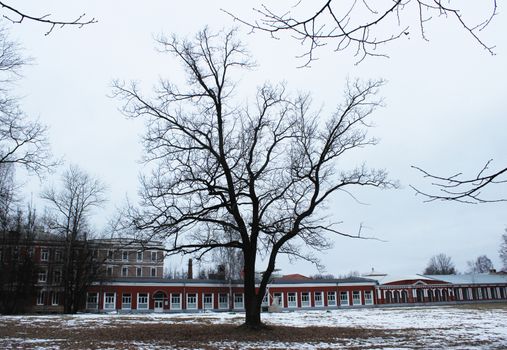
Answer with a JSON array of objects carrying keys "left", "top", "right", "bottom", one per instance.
[{"left": 0, "top": 305, "right": 507, "bottom": 349}]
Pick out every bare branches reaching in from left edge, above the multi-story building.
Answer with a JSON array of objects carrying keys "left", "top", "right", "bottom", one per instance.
[{"left": 0, "top": 29, "right": 57, "bottom": 176}]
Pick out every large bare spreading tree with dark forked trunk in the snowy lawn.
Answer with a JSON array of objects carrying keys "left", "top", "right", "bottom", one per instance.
[{"left": 114, "top": 29, "right": 394, "bottom": 328}]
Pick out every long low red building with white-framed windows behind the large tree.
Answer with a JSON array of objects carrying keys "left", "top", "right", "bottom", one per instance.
[{"left": 86, "top": 274, "right": 507, "bottom": 312}]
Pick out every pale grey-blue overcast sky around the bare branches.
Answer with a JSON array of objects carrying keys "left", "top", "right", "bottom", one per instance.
[{"left": 3, "top": 0, "right": 507, "bottom": 275}]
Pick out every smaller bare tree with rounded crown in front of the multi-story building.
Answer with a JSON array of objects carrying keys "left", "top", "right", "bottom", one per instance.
[{"left": 41, "top": 166, "right": 105, "bottom": 313}]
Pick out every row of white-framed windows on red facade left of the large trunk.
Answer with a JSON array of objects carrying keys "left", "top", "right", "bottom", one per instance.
[{"left": 86, "top": 292, "right": 244, "bottom": 311}]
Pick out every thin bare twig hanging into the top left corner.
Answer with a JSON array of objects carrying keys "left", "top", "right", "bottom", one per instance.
[{"left": 0, "top": 1, "right": 97, "bottom": 35}]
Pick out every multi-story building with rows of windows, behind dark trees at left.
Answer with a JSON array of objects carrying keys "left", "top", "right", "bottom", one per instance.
[{"left": 0, "top": 235, "right": 164, "bottom": 313}]
